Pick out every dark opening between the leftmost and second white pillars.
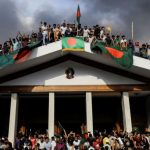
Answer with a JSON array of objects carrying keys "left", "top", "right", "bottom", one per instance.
[{"left": 18, "top": 93, "right": 48, "bottom": 134}]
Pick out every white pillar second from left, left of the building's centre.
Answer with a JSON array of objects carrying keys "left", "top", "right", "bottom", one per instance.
[{"left": 48, "top": 93, "right": 55, "bottom": 138}]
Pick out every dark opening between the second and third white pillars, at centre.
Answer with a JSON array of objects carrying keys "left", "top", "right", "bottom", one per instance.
[{"left": 55, "top": 93, "right": 86, "bottom": 133}]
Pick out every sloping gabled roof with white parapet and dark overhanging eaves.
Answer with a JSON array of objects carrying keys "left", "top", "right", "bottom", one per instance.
[{"left": 0, "top": 41, "right": 150, "bottom": 83}]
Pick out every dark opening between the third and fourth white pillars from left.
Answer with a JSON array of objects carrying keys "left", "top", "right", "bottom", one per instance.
[{"left": 93, "top": 93, "right": 122, "bottom": 132}]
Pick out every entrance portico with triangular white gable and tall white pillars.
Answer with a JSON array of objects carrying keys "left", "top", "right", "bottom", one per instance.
[{"left": 0, "top": 42, "right": 150, "bottom": 148}]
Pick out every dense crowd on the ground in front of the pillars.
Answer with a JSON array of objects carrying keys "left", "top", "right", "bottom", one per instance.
[{"left": 0, "top": 130, "right": 150, "bottom": 150}]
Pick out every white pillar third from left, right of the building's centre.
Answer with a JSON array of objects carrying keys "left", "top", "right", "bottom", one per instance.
[{"left": 86, "top": 92, "right": 93, "bottom": 134}]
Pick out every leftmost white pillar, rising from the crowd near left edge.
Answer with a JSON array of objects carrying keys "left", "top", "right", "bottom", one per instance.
[{"left": 8, "top": 93, "right": 18, "bottom": 147}]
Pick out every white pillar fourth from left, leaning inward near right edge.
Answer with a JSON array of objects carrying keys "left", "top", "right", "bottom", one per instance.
[{"left": 122, "top": 92, "right": 132, "bottom": 133}]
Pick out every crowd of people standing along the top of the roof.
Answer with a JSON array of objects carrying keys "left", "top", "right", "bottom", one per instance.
[{"left": 0, "top": 22, "right": 150, "bottom": 59}]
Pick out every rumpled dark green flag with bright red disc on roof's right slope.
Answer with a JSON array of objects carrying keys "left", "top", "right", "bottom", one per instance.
[{"left": 91, "top": 40, "right": 133, "bottom": 68}]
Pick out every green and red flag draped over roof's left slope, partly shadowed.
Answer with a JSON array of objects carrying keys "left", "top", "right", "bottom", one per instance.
[{"left": 0, "top": 42, "right": 41, "bottom": 68}]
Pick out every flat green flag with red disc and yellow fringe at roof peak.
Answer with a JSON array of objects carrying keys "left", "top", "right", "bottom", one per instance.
[{"left": 62, "top": 37, "right": 84, "bottom": 51}]
